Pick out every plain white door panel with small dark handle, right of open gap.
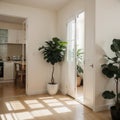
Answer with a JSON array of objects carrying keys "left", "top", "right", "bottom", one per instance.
[{"left": 84, "top": 4, "right": 95, "bottom": 110}]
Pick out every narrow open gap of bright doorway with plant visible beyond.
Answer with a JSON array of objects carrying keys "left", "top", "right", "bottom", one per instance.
[{"left": 76, "top": 12, "right": 85, "bottom": 103}]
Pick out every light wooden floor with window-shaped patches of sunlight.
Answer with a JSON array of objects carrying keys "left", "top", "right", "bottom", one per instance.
[{"left": 0, "top": 83, "right": 111, "bottom": 120}]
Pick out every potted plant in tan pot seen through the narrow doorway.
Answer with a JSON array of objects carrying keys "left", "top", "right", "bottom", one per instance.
[{"left": 76, "top": 49, "right": 83, "bottom": 87}]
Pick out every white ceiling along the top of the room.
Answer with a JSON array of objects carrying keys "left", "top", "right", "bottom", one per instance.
[{"left": 0, "top": 0, "right": 73, "bottom": 10}]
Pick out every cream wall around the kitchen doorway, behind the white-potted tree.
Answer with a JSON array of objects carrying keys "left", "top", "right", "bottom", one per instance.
[{"left": 0, "top": 2, "right": 60, "bottom": 94}]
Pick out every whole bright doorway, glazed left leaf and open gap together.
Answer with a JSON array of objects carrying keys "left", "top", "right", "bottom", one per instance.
[{"left": 67, "top": 12, "right": 85, "bottom": 103}]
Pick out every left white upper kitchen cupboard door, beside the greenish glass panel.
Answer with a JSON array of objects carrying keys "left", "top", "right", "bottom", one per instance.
[{"left": 8, "top": 29, "right": 18, "bottom": 43}]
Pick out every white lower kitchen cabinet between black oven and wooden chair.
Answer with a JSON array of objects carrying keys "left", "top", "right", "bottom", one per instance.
[{"left": 4, "top": 61, "right": 14, "bottom": 80}]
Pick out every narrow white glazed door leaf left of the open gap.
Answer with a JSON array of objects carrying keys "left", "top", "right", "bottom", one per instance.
[{"left": 67, "top": 20, "right": 76, "bottom": 98}]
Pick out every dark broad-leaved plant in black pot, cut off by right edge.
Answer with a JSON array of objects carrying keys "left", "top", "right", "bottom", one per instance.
[{"left": 102, "top": 39, "right": 120, "bottom": 120}]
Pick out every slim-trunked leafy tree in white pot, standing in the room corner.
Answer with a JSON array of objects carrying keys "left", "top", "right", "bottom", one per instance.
[{"left": 39, "top": 37, "right": 67, "bottom": 95}]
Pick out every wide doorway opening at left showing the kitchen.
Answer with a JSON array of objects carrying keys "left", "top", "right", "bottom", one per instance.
[{"left": 0, "top": 15, "right": 26, "bottom": 98}]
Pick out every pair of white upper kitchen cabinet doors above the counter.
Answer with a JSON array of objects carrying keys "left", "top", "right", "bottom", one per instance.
[{"left": 8, "top": 29, "right": 25, "bottom": 44}]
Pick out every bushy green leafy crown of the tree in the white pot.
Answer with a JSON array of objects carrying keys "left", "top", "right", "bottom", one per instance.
[{"left": 39, "top": 37, "right": 67, "bottom": 65}]
